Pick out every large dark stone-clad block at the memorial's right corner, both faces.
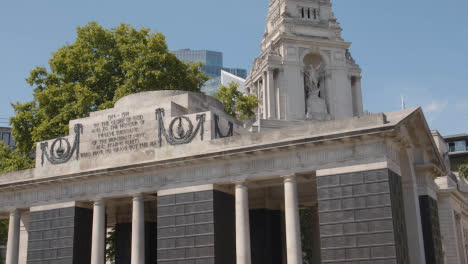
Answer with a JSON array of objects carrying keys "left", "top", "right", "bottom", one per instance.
[{"left": 317, "top": 169, "right": 409, "bottom": 264}]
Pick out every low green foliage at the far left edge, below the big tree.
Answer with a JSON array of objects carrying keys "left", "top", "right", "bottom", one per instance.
[{"left": 0, "top": 141, "right": 33, "bottom": 174}]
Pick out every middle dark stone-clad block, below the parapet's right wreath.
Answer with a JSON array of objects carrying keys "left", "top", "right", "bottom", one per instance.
[{"left": 157, "top": 190, "right": 236, "bottom": 264}]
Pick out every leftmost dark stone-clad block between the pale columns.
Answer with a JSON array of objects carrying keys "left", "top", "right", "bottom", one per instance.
[{"left": 27, "top": 207, "right": 93, "bottom": 264}]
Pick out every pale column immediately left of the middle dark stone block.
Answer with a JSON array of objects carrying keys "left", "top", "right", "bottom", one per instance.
[{"left": 131, "top": 194, "right": 145, "bottom": 264}]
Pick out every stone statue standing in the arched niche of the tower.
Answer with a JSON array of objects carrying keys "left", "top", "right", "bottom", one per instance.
[{"left": 304, "top": 63, "right": 328, "bottom": 119}]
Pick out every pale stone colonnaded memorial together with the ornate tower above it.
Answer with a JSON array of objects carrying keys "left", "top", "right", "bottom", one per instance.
[{"left": 0, "top": 0, "right": 468, "bottom": 264}]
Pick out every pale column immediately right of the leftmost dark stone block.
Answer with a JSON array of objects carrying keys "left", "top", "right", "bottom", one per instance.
[{"left": 91, "top": 199, "right": 106, "bottom": 264}]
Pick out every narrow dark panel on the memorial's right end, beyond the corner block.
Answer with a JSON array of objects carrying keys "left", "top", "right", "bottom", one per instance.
[{"left": 419, "top": 195, "right": 444, "bottom": 264}]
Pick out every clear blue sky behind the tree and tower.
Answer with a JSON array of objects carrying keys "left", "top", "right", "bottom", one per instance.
[{"left": 0, "top": 0, "right": 468, "bottom": 135}]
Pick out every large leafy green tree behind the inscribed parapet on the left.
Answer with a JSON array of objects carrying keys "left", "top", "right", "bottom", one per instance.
[{"left": 10, "top": 22, "right": 208, "bottom": 157}]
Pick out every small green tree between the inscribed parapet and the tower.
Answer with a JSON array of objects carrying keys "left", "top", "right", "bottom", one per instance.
[{"left": 214, "top": 82, "right": 259, "bottom": 120}]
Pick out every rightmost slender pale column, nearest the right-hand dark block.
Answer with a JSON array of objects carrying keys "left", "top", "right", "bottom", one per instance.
[{"left": 284, "top": 175, "right": 302, "bottom": 264}]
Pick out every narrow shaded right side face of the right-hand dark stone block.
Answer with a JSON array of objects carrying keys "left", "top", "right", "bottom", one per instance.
[{"left": 388, "top": 170, "right": 409, "bottom": 264}]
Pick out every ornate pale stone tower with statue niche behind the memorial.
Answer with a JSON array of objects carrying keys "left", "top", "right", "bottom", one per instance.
[{"left": 246, "top": 0, "right": 363, "bottom": 128}]
